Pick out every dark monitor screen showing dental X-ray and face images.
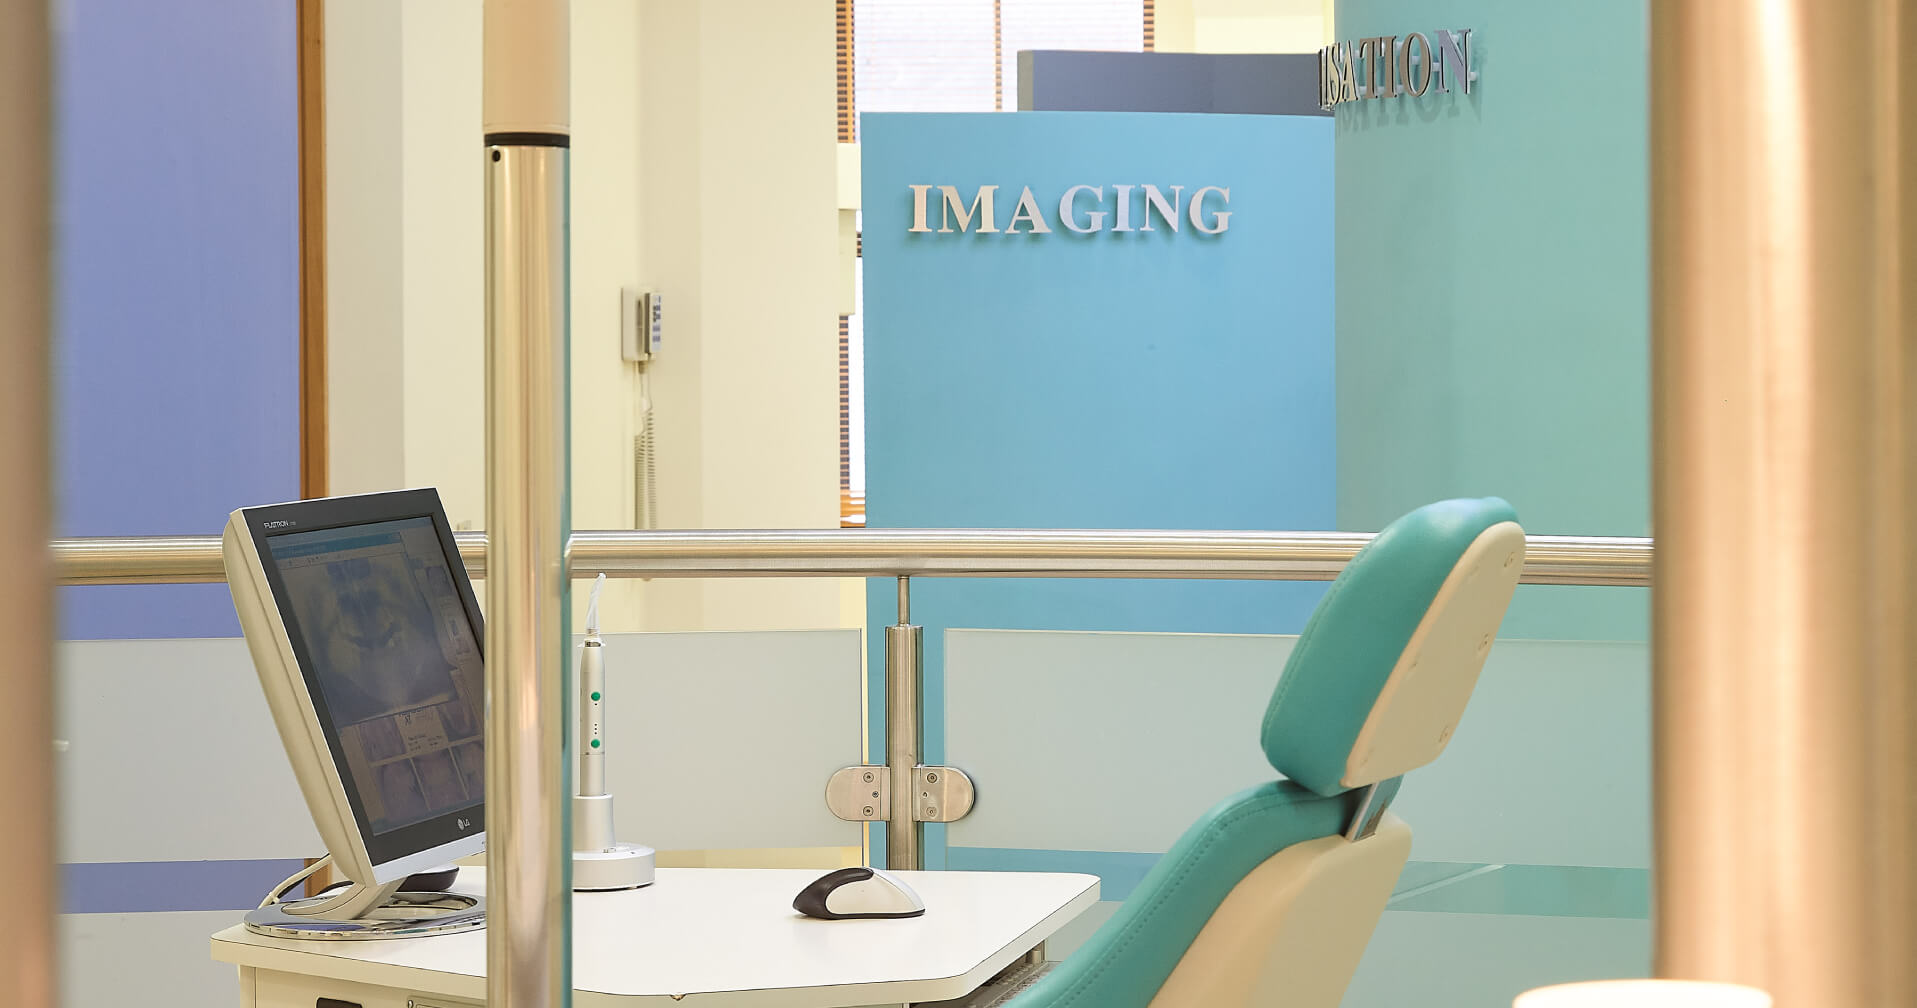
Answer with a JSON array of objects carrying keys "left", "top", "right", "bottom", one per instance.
[{"left": 263, "top": 515, "right": 485, "bottom": 862}]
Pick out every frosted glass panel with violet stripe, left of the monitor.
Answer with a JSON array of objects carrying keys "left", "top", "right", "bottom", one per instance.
[{"left": 56, "top": 638, "right": 324, "bottom": 1008}]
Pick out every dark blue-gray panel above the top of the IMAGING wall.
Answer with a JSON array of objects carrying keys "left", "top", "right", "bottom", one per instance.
[{"left": 1018, "top": 50, "right": 1330, "bottom": 115}]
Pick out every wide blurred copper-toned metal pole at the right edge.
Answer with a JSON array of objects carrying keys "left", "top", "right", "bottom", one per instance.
[{"left": 1651, "top": 0, "right": 1917, "bottom": 1008}]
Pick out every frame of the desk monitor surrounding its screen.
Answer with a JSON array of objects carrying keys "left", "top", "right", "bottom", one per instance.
[{"left": 240, "top": 489, "right": 485, "bottom": 874}]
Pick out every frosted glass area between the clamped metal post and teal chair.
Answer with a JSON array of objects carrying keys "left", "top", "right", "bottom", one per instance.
[{"left": 945, "top": 630, "right": 1296, "bottom": 855}]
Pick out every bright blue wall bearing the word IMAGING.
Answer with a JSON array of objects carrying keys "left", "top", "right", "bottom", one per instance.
[{"left": 861, "top": 111, "right": 1336, "bottom": 866}]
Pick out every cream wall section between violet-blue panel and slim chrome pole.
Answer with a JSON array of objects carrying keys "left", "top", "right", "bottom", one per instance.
[{"left": 326, "top": 0, "right": 485, "bottom": 529}]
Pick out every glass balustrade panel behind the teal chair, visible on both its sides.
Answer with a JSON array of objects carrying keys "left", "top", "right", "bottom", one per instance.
[{"left": 943, "top": 613, "right": 1651, "bottom": 1008}]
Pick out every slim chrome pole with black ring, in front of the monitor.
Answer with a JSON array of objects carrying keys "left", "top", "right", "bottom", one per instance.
[{"left": 483, "top": 0, "right": 571, "bottom": 1008}]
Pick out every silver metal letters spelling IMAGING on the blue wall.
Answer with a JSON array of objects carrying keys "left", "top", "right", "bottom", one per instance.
[{"left": 905, "top": 186, "right": 1231, "bottom": 234}]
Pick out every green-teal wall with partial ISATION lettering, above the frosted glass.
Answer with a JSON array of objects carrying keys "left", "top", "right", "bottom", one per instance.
[{"left": 1334, "top": 0, "right": 1651, "bottom": 640}]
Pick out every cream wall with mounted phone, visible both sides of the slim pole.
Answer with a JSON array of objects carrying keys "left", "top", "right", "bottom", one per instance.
[{"left": 326, "top": 0, "right": 842, "bottom": 629}]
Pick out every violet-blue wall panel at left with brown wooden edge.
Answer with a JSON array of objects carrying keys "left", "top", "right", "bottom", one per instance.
[{"left": 52, "top": 0, "right": 299, "bottom": 640}]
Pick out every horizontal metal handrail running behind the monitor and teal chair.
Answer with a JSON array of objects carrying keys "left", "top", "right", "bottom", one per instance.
[{"left": 52, "top": 529, "right": 1651, "bottom": 586}]
